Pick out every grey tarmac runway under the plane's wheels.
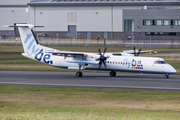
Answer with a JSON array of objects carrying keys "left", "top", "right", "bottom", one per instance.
[{"left": 0, "top": 71, "right": 180, "bottom": 91}]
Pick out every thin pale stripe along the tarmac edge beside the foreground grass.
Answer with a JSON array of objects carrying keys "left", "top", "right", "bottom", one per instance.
[{"left": 0, "top": 82, "right": 180, "bottom": 90}]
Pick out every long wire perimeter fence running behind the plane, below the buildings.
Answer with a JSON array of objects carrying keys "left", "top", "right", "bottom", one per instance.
[{"left": 0, "top": 37, "right": 180, "bottom": 48}]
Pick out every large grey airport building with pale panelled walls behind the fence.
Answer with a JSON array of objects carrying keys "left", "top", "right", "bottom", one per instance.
[{"left": 0, "top": 0, "right": 180, "bottom": 40}]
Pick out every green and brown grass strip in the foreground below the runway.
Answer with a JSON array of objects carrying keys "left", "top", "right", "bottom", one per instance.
[{"left": 0, "top": 86, "right": 180, "bottom": 120}]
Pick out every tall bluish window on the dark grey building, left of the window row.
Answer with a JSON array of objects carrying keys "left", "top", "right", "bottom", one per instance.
[{"left": 124, "top": 20, "right": 134, "bottom": 32}]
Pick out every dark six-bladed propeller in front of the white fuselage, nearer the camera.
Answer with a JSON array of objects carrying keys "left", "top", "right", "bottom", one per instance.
[{"left": 96, "top": 48, "right": 109, "bottom": 69}]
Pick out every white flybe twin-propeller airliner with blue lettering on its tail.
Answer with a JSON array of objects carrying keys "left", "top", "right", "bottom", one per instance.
[{"left": 6, "top": 24, "right": 176, "bottom": 78}]
